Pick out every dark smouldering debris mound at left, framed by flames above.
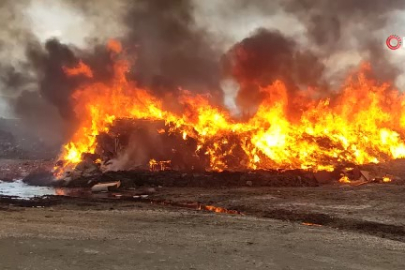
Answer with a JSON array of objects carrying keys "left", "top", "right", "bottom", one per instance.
[{"left": 95, "top": 119, "right": 209, "bottom": 171}]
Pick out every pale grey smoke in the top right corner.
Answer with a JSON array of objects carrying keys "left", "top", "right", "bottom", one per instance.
[{"left": 282, "top": 0, "right": 405, "bottom": 81}]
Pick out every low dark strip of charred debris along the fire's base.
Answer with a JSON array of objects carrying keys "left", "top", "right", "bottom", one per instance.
[{"left": 62, "top": 170, "right": 318, "bottom": 188}]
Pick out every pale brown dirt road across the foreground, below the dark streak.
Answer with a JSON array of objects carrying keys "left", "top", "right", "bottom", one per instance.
[{"left": 0, "top": 206, "right": 405, "bottom": 270}]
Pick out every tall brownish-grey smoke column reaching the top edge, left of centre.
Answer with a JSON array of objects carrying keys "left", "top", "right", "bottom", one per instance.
[{"left": 125, "top": 0, "right": 221, "bottom": 103}]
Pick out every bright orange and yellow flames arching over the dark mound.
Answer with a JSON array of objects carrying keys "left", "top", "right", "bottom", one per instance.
[{"left": 54, "top": 41, "right": 405, "bottom": 175}]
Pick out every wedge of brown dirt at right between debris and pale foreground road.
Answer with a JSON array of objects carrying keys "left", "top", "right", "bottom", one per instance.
[{"left": 150, "top": 184, "right": 405, "bottom": 242}]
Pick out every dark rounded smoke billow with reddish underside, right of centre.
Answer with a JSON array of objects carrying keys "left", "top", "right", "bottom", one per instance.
[{"left": 223, "top": 29, "right": 324, "bottom": 114}]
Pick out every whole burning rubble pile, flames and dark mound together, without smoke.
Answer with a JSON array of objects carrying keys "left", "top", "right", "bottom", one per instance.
[{"left": 41, "top": 41, "right": 405, "bottom": 189}]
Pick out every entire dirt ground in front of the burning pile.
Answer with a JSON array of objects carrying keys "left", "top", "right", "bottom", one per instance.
[{"left": 0, "top": 159, "right": 405, "bottom": 270}]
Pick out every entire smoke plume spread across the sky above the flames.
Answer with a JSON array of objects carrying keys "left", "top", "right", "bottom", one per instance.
[{"left": 0, "top": 0, "right": 405, "bottom": 157}]
